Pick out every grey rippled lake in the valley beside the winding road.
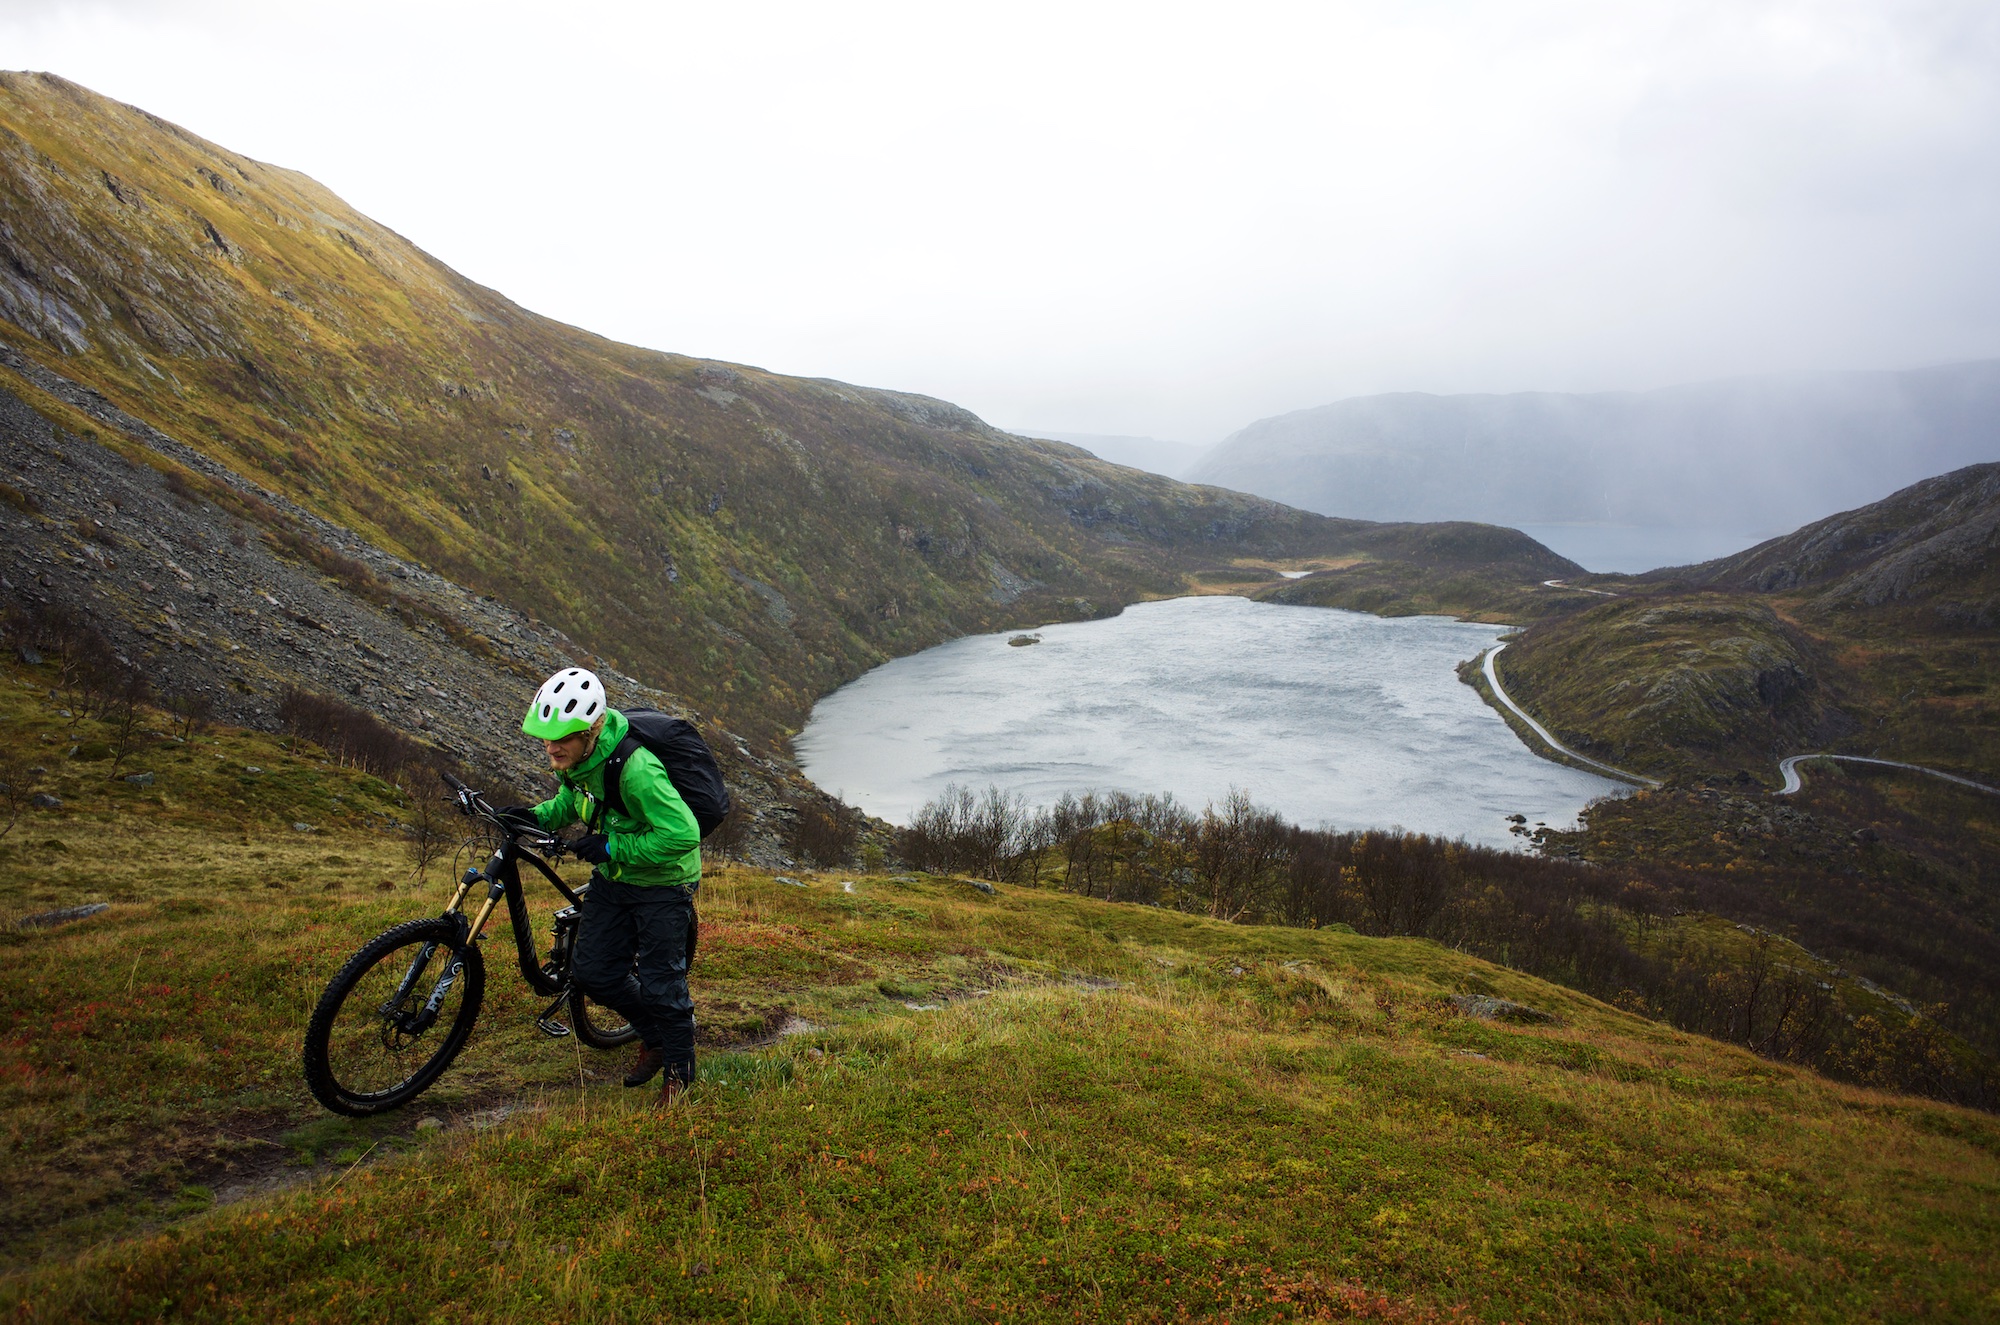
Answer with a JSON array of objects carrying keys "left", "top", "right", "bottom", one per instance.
[{"left": 796, "top": 596, "right": 1622, "bottom": 845}]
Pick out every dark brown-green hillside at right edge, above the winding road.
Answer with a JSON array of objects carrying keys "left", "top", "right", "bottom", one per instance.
[{"left": 1498, "top": 464, "right": 2000, "bottom": 785}]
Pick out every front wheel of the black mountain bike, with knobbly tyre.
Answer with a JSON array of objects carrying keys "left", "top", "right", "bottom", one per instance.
[{"left": 306, "top": 919, "right": 486, "bottom": 1117}]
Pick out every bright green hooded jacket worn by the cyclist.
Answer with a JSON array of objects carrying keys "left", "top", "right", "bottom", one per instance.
[{"left": 534, "top": 709, "right": 702, "bottom": 889}]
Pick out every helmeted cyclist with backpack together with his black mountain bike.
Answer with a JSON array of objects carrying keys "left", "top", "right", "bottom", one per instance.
[{"left": 302, "top": 667, "right": 730, "bottom": 1117}]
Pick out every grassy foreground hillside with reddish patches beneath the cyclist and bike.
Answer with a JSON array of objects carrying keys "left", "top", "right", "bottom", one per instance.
[{"left": 0, "top": 679, "right": 2000, "bottom": 1321}]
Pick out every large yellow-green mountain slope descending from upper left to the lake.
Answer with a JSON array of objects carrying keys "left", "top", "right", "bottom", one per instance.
[{"left": 0, "top": 74, "right": 1552, "bottom": 749}]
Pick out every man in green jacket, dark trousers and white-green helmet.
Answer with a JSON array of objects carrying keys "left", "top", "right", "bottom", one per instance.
[{"left": 506, "top": 667, "right": 702, "bottom": 1105}]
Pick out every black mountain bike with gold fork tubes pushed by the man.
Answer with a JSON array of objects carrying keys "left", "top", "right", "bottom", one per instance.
[{"left": 306, "top": 773, "right": 638, "bottom": 1117}]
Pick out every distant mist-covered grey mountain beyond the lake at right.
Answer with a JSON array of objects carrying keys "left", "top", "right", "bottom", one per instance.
[{"left": 1190, "top": 360, "right": 2000, "bottom": 528}]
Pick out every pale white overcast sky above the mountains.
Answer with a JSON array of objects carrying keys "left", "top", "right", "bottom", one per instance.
[{"left": 0, "top": 0, "right": 2000, "bottom": 442}]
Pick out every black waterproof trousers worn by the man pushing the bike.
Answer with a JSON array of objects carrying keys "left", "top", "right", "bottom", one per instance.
[{"left": 574, "top": 875, "right": 696, "bottom": 1081}]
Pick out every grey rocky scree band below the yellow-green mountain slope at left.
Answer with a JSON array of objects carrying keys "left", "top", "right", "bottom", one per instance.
[{"left": 0, "top": 374, "right": 818, "bottom": 855}]
